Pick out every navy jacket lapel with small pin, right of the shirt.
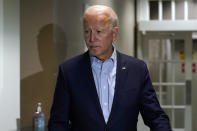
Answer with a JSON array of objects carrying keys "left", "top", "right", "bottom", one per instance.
[{"left": 107, "top": 51, "right": 127, "bottom": 124}]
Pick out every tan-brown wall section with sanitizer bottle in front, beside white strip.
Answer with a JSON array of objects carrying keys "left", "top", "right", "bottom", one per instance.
[{"left": 20, "top": 0, "right": 54, "bottom": 128}]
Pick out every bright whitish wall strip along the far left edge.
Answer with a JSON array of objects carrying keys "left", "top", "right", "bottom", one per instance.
[{"left": 0, "top": 0, "right": 20, "bottom": 131}]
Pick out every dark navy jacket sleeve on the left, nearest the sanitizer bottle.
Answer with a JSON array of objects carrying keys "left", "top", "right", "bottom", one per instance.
[{"left": 48, "top": 66, "right": 70, "bottom": 131}]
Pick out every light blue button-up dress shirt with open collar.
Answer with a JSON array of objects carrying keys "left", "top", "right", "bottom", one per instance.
[{"left": 90, "top": 48, "right": 117, "bottom": 123}]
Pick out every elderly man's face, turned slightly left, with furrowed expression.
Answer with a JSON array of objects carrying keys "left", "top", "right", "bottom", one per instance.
[{"left": 84, "top": 13, "right": 118, "bottom": 61}]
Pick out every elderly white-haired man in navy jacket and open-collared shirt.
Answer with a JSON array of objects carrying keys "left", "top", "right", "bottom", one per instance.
[{"left": 48, "top": 5, "right": 171, "bottom": 131}]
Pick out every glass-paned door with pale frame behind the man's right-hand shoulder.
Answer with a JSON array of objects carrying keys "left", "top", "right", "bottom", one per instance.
[{"left": 138, "top": 32, "right": 192, "bottom": 131}]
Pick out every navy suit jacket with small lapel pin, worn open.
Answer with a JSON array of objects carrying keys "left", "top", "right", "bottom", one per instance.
[{"left": 48, "top": 52, "right": 171, "bottom": 131}]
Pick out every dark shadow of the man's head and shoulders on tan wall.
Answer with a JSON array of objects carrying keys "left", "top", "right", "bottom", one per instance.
[{"left": 21, "top": 24, "right": 66, "bottom": 128}]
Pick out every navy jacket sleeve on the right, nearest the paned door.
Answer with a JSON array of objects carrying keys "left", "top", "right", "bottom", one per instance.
[{"left": 140, "top": 63, "right": 172, "bottom": 131}]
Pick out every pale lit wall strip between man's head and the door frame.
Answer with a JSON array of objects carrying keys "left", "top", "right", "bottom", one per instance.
[{"left": 113, "top": 0, "right": 135, "bottom": 56}]
